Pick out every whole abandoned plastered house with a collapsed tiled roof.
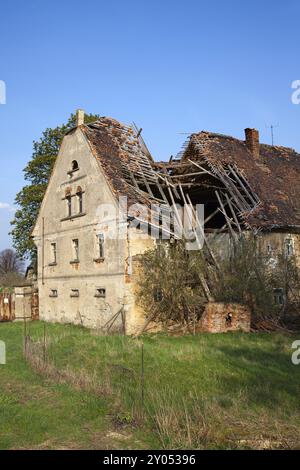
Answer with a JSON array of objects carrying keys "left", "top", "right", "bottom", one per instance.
[{"left": 32, "top": 111, "right": 300, "bottom": 334}]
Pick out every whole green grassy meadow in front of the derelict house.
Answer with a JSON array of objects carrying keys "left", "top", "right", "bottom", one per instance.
[{"left": 0, "top": 322, "right": 300, "bottom": 449}]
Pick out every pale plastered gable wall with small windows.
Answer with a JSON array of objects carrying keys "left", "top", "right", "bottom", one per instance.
[{"left": 33, "top": 129, "right": 126, "bottom": 327}]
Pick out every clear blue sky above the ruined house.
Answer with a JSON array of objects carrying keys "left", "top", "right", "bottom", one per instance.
[{"left": 0, "top": 0, "right": 300, "bottom": 249}]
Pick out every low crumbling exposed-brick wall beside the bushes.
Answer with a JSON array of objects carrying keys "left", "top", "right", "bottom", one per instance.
[{"left": 200, "top": 302, "right": 251, "bottom": 333}]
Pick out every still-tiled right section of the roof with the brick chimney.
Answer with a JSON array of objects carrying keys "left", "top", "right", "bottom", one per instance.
[{"left": 182, "top": 129, "right": 300, "bottom": 229}]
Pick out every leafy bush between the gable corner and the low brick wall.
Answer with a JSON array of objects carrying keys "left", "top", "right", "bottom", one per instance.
[{"left": 139, "top": 240, "right": 207, "bottom": 324}]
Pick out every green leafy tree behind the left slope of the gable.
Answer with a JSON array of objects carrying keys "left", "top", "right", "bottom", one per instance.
[{"left": 11, "top": 114, "right": 99, "bottom": 262}]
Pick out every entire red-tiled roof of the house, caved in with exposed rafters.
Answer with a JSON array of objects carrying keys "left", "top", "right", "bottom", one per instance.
[{"left": 80, "top": 117, "right": 300, "bottom": 234}]
